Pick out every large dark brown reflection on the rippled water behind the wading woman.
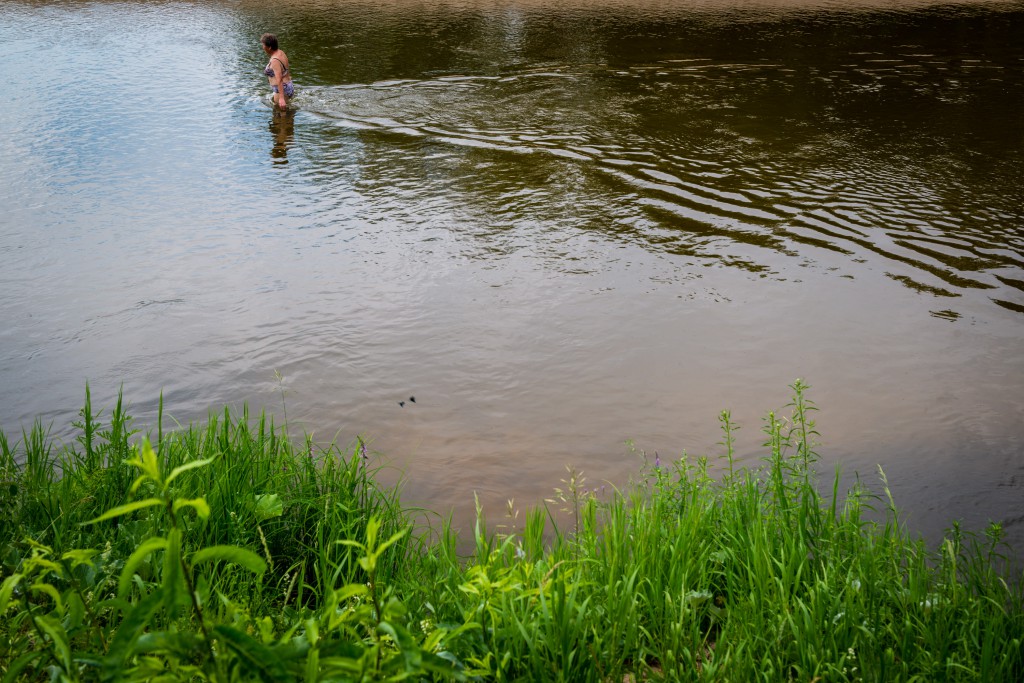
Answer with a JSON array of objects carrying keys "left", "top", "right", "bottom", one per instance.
[{"left": 260, "top": 3, "right": 1024, "bottom": 310}]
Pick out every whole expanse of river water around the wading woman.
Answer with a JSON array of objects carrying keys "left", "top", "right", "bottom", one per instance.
[{"left": 0, "top": 0, "right": 1024, "bottom": 545}]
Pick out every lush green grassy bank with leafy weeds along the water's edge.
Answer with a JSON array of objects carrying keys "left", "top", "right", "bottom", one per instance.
[{"left": 0, "top": 382, "right": 1024, "bottom": 682}]
